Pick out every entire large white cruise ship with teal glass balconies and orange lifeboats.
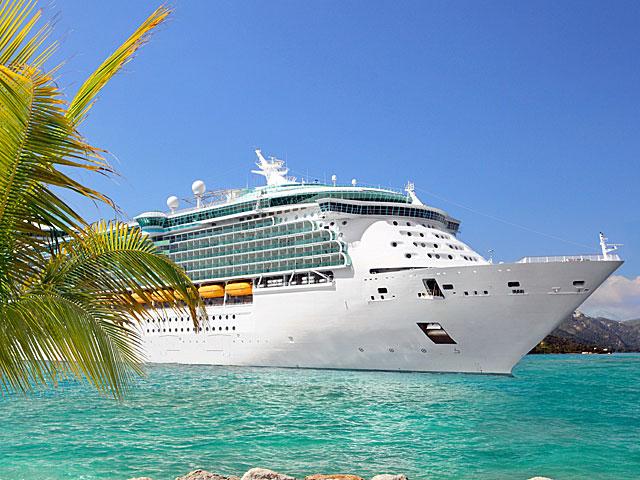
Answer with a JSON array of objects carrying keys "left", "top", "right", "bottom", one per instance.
[{"left": 135, "top": 150, "right": 622, "bottom": 374}]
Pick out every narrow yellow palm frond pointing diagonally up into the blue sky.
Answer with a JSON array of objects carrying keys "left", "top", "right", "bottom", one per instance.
[{"left": 67, "top": 6, "right": 171, "bottom": 125}]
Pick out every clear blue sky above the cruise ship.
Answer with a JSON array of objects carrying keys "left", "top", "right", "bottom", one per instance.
[{"left": 48, "top": 0, "right": 640, "bottom": 316}]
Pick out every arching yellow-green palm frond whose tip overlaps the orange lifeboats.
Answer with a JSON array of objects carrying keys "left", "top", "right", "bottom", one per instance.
[{"left": 35, "top": 221, "right": 206, "bottom": 327}]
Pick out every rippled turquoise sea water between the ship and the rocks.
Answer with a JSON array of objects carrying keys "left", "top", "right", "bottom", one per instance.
[{"left": 0, "top": 355, "right": 640, "bottom": 480}]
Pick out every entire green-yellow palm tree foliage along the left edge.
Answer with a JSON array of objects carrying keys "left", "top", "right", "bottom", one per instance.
[{"left": 0, "top": 0, "right": 204, "bottom": 397}]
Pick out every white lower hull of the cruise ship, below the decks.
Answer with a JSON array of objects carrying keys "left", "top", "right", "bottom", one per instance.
[{"left": 142, "top": 260, "right": 622, "bottom": 374}]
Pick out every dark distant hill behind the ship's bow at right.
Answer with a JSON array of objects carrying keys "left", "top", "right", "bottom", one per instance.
[{"left": 530, "top": 312, "right": 640, "bottom": 353}]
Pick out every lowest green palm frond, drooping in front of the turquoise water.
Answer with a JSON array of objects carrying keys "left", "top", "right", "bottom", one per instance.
[{"left": 0, "top": 293, "right": 142, "bottom": 397}]
